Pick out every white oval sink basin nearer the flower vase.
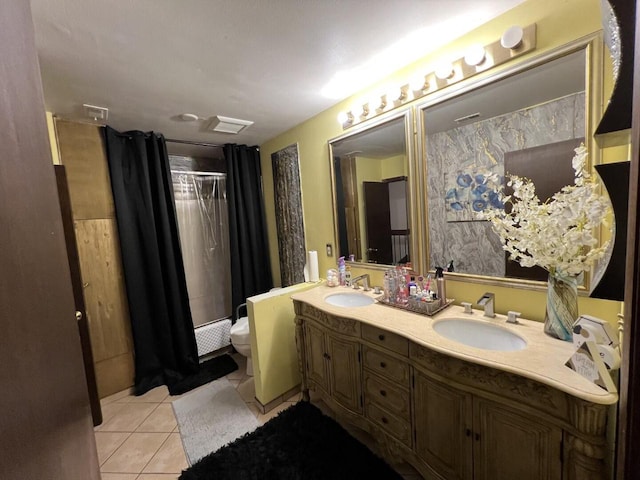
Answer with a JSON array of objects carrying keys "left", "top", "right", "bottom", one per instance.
[{"left": 433, "top": 318, "right": 527, "bottom": 352}]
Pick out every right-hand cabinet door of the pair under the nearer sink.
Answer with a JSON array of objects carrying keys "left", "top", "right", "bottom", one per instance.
[{"left": 473, "top": 398, "right": 562, "bottom": 480}]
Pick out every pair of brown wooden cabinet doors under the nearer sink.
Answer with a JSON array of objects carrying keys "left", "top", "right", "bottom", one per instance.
[{"left": 414, "top": 371, "right": 562, "bottom": 480}]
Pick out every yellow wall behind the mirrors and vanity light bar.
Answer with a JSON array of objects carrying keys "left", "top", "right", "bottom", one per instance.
[{"left": 260, "top": 0, "right": 629, "bottom": 323}]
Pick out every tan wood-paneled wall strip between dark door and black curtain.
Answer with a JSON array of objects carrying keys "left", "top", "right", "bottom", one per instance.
[{"left": 55, "top": 119, "right": 134, "bottom": 398}]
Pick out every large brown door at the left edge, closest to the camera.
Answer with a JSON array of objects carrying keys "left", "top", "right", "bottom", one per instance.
[{"left": 0, "top": 0, "right": 100, "bottom": 480}]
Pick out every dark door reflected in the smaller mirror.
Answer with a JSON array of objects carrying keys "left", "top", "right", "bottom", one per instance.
[{"left": 362, "top": 182, "right": 393, "bottom": 265}]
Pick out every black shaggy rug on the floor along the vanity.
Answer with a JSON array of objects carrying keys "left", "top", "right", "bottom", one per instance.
[{"left": 180, "top": 402, "right": 402, "bottom": 480}]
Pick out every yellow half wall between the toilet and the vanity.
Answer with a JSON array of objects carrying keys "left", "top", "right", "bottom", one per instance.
[{"left": 247, "top": 283, "right": 317, "bottom": 405}]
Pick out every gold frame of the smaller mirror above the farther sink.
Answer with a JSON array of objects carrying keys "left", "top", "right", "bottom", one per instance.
[{"left": 327, "top": 107, "right": 424, "bottom": 270}]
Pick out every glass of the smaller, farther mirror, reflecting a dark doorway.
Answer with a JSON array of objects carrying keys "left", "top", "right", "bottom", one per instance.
[{"left": 329, "top": 116, "right": 411, "bottom": 265}]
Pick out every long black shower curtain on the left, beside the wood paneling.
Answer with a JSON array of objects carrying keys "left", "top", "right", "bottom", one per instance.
[{"left": 105, "top": 127, "right": 198, "bottom": 395}]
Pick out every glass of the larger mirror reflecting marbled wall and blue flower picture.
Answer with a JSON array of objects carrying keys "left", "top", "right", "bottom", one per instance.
[{"left": 422, "top": 50, "right": 586, "bottom": 280}]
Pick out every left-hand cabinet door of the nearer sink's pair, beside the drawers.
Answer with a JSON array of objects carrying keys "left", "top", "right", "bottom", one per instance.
[{"left": 414, "top": 372, "right": 472, "bottom": 480}]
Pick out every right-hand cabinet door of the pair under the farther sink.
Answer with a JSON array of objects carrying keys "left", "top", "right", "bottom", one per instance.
[{"left": 327, "top": 334, "right": 362, "bottom": 413}]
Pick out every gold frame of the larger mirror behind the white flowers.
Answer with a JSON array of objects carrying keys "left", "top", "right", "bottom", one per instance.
[{"left": 413, "top": 32, "right": 603, "bottom": 290}]
